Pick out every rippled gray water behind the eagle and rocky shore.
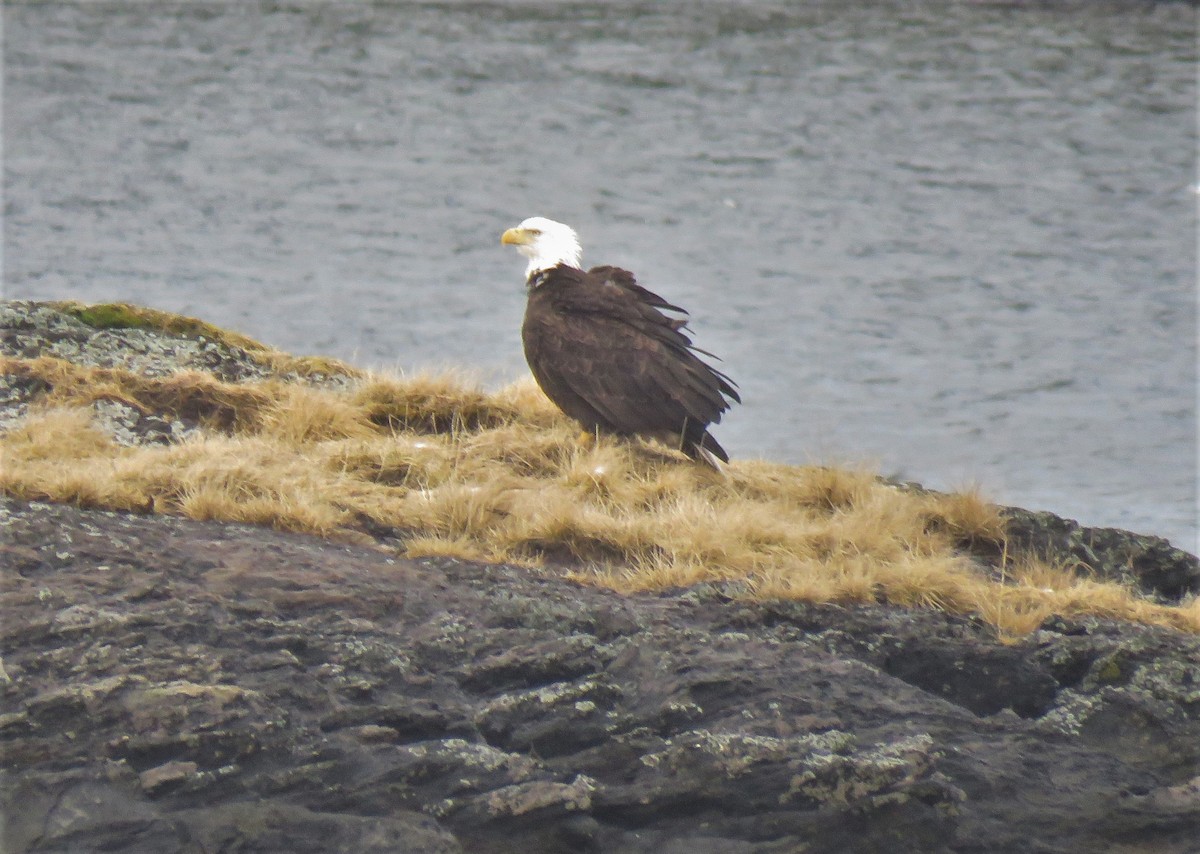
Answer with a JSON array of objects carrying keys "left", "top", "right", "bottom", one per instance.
[{"left": 4, "top": 0, "right": 1196, "bottom": 549}]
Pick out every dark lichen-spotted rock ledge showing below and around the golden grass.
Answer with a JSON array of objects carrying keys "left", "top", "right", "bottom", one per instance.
[{"left": 0, "top": 302, "right": 1200, "bottom": 854}]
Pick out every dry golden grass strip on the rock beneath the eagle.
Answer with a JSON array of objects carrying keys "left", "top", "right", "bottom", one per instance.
[{"left": 0, "top": 350, "right": 1200, "bottom": 637}]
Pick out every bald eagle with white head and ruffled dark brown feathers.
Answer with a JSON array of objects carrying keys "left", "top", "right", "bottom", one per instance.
[{"left": 500, "top": 216, "right": 742, "bottom": 468}]
